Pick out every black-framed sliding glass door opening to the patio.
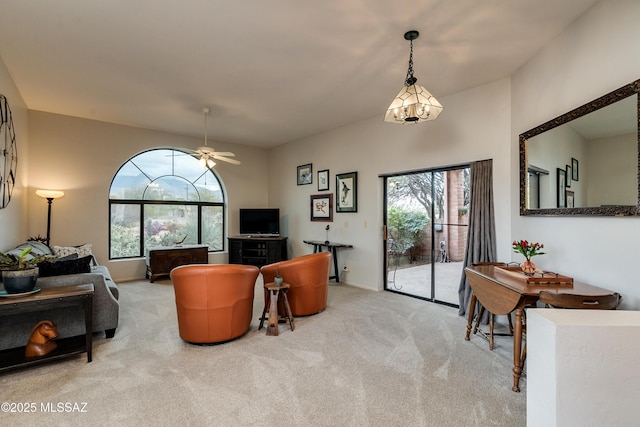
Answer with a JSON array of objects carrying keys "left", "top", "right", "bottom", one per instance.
[{"left": 383, "top": 165, "right": 469, "bottom": 306}]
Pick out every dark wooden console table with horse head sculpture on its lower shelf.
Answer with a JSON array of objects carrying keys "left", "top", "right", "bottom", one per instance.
[{"left": 0, "top": 284, "right": 93, "bottom": 371}]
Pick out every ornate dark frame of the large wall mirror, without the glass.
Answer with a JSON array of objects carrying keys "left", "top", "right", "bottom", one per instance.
[{"left": 520, "top": 80, "right": 640, "bottom": 216}]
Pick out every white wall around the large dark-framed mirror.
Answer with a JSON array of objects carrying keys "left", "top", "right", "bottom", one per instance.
[{"left": 512, "top": 0, "right": 640, "bottom": 309}]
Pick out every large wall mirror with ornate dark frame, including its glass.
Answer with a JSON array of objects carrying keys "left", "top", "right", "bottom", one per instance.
[{"left": 520, "top": 80, "right": 640, "bottom": 216}]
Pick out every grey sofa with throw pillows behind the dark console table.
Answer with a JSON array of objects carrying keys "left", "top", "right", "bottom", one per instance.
[{"left": 0, "top": 242, "right": 120, "bottom": 350}]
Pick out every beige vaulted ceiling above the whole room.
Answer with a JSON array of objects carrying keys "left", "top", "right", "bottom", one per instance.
[{"left": 0, "top": 0, "right": 596, "bottom": 147}]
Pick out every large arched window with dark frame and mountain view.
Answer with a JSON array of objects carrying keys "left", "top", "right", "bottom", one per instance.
[{"left": 109, "top": 148, "right": 225, "bottom": 259}]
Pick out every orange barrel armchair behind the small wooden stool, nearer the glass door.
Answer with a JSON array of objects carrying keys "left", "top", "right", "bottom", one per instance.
[{"left": 261, "top": 252, "right": 331, "bottom": 316}]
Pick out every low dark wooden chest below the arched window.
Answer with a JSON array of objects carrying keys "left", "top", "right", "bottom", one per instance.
[{"left": 147, "top": 245, "right": 209, "bottom": 283}]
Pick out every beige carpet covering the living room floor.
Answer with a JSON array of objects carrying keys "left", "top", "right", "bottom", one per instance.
[{"left": 0, "top": 280, "right": 526, "bottom": 426}]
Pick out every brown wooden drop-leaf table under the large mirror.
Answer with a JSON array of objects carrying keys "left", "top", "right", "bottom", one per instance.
[{"left": 464, "top": 265, "right": 614, "bottom": 392}]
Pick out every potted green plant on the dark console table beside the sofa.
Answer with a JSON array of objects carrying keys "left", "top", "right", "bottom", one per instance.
[{"left": 0, "top": 246, "right": 47, "bottom": 294}]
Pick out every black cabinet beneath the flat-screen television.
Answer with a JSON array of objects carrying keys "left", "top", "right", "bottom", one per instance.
[{"left": 229, "top": 237, "right": 287, "bottom": 267}]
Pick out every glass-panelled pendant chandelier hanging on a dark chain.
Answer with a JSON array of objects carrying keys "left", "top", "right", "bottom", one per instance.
[{"left": 384, "top": 30, "right": 442, "bottom": 125}]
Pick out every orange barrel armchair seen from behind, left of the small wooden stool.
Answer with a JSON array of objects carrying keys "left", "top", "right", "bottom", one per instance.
[{"left": 171, "top": 264, "right": 260, "bottom": 344}]
